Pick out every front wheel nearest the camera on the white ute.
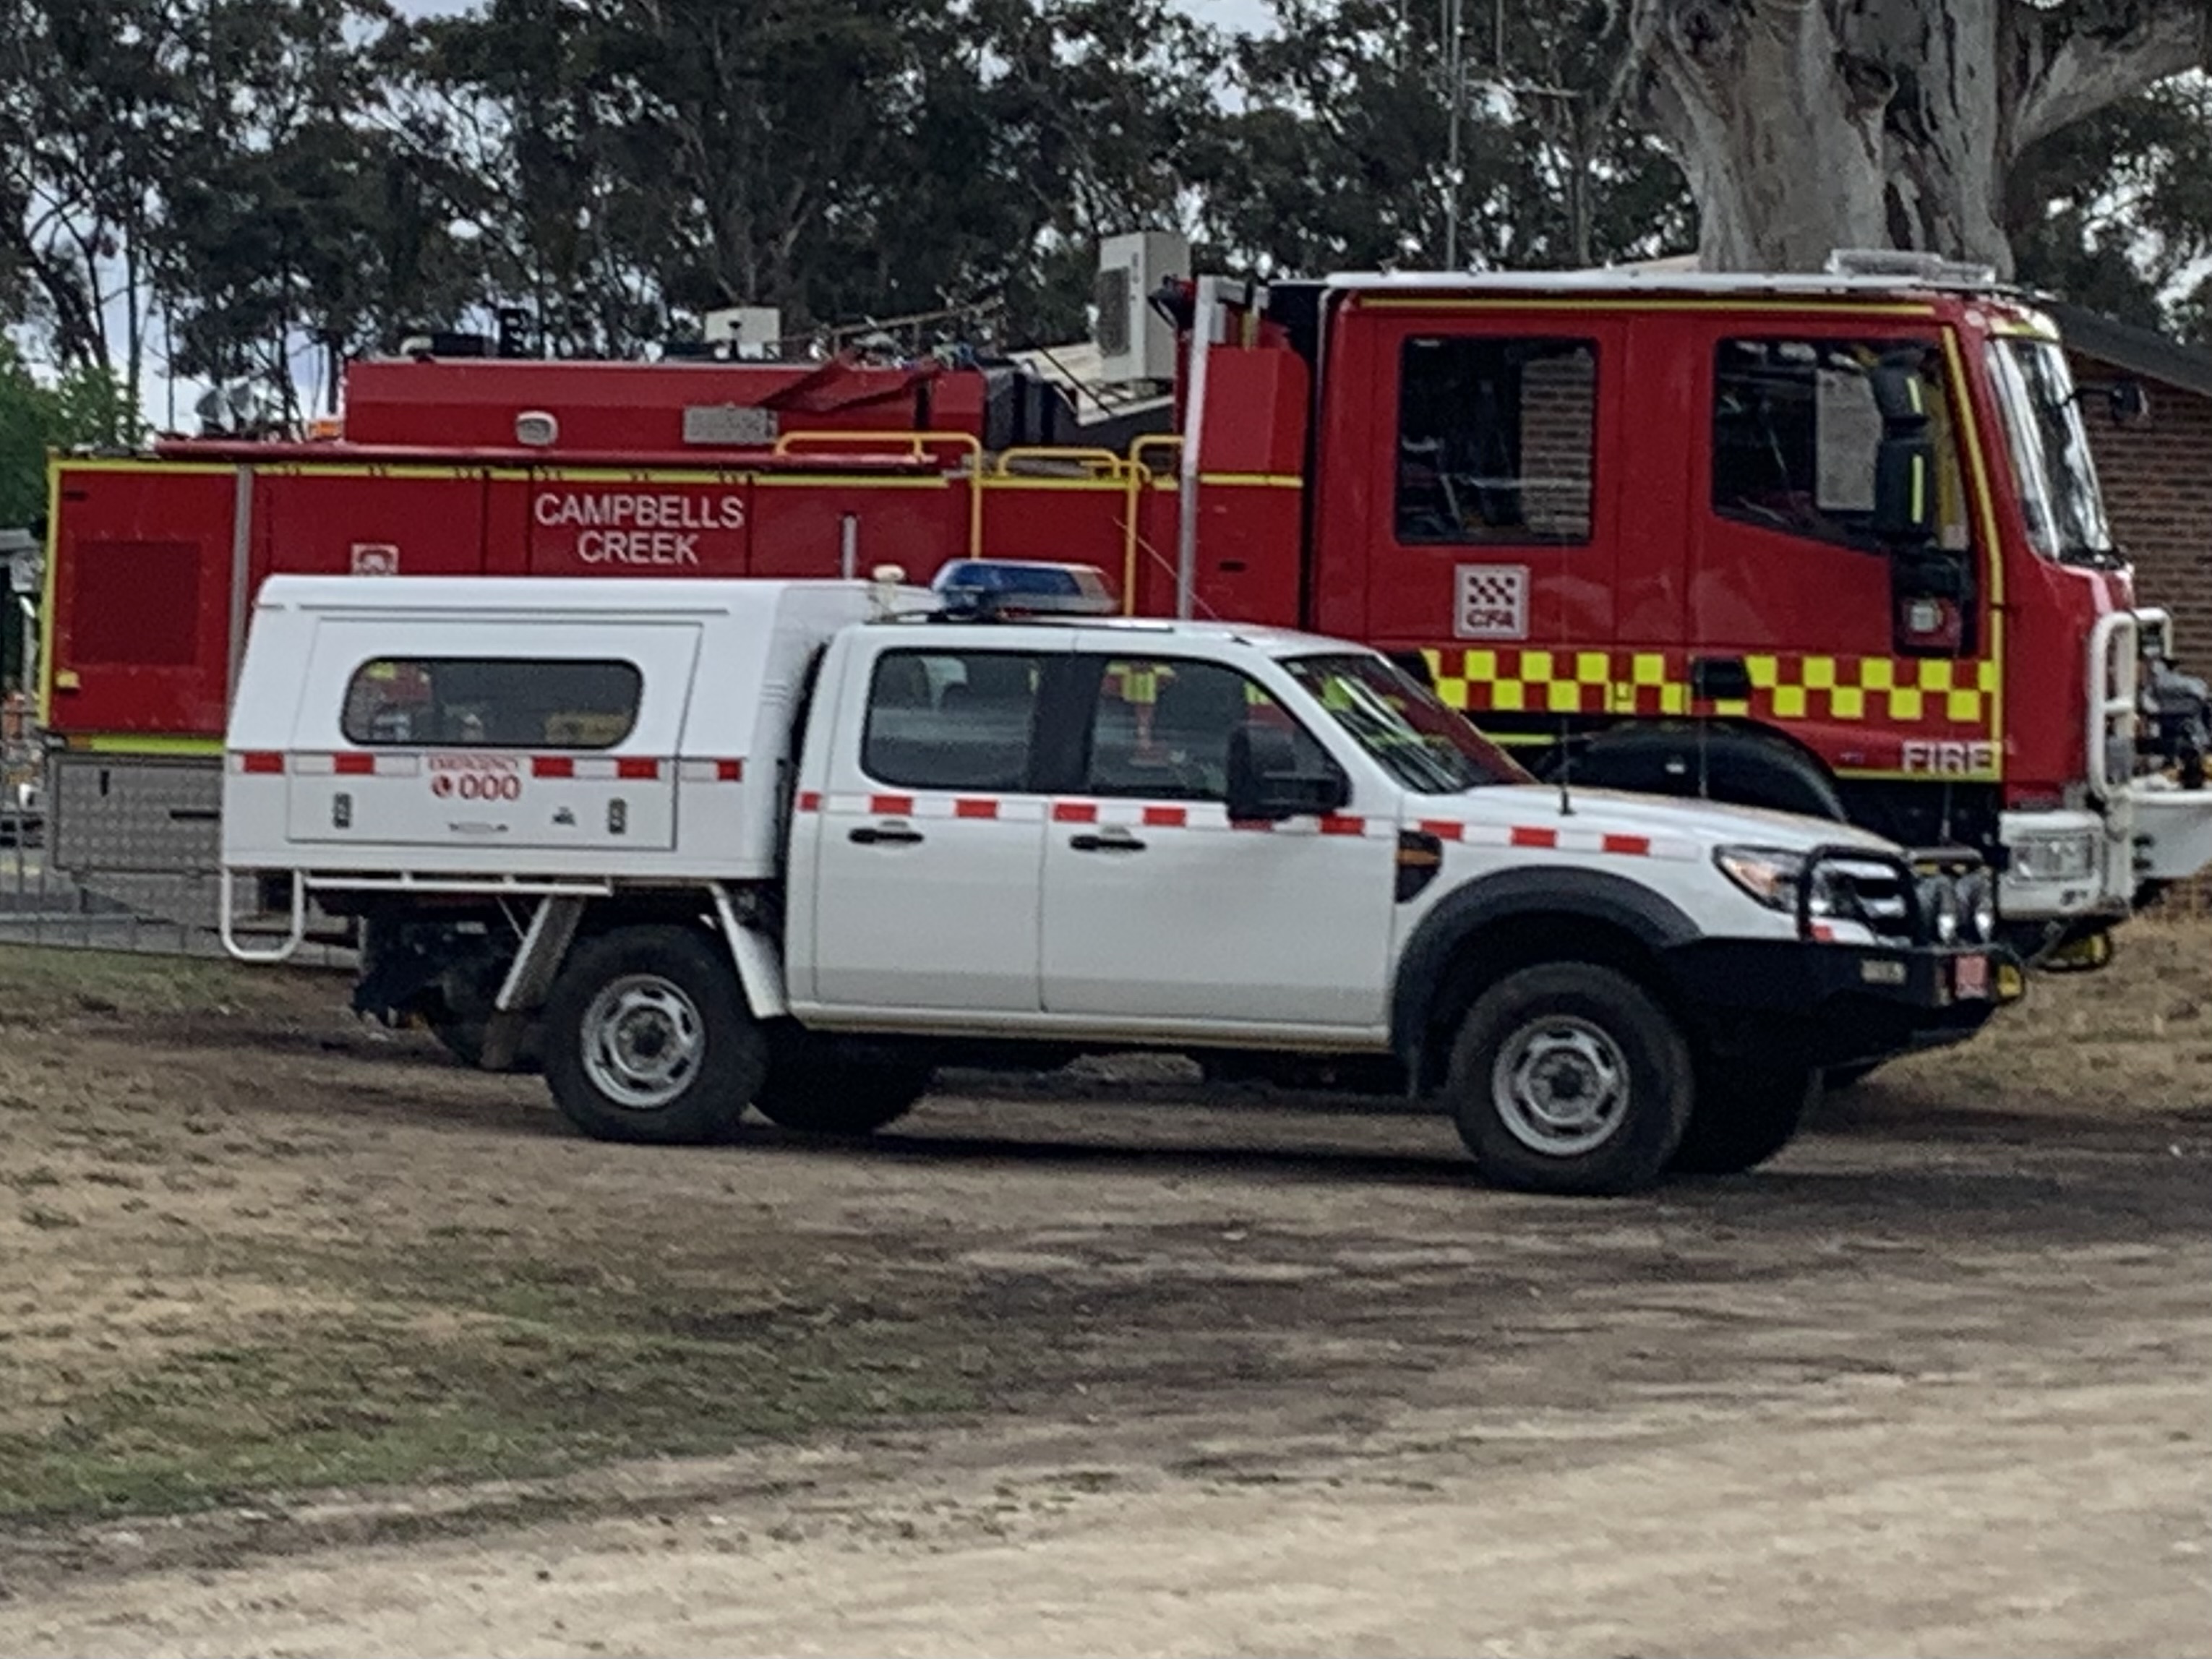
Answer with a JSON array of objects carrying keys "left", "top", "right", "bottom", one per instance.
[{"left": 1444, "top": 962, "right": 1694, "bottom": 1192}]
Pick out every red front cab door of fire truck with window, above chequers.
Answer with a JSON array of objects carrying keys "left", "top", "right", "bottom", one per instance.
[{"left": 1686, "top": 319, "right": 1971, "bottom": 668}]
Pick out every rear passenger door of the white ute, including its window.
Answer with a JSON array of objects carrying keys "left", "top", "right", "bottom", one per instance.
[{"left": 799, "top": 630, "right": 1066, "bottom": 1013}]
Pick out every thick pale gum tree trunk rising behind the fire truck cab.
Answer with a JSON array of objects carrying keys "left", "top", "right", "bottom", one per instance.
[{"left": 1630, "top": 0, "right": 2212, "bottom": 274}]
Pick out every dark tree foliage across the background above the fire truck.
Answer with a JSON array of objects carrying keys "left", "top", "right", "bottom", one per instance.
[{"left": 0, "top": 0, "right": 2212, "bottom": 411}]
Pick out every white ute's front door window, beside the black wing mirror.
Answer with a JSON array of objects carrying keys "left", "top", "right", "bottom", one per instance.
[{"left": 1079, "top": 657, "right": 1334, "bottom": 801}]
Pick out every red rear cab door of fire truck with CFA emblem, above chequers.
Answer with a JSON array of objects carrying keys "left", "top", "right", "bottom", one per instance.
[{"left": 1353, "top": 309, "right": 1626, "bottom": 664}]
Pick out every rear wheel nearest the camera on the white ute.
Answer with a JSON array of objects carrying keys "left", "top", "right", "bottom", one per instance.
[{"left": 544, "top": 927, "right": 768, "bottom": 1144}]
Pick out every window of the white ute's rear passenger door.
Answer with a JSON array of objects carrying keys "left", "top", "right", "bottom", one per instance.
[{"left": 860, "top": 651, "right": 1044, "bottom": 789}]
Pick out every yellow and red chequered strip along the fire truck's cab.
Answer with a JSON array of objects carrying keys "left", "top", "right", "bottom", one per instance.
[{"left": 1423, "top": 646, "right": 1997, "bottom": 730}]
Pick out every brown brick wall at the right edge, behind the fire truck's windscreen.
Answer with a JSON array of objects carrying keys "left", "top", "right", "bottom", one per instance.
[{"left": 2072, "top": 354, "right": 2212, "bottom": 674}]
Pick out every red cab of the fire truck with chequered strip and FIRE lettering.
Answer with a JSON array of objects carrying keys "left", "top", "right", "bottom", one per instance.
[{"left": 1175, "top": 263, "right": 2212, "bottom": 960}]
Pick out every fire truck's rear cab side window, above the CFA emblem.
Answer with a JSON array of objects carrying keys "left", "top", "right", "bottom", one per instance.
[{"left": 1398, "top": 336, "right": 1597, "bottom": 546}]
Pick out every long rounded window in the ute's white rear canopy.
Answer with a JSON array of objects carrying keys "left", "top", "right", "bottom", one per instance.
[{"left": 340, "top": 657, "right": 646, "bottom": 750}]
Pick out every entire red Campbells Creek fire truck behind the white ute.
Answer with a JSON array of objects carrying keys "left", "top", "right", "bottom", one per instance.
[{"left": 44, "top": 261, "right": 2212, "bottom": 964}]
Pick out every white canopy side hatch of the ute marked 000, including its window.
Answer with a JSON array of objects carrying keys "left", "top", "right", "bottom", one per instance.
[{"left": 288, "top": 617, "right": 699, "bottom": 852}]
